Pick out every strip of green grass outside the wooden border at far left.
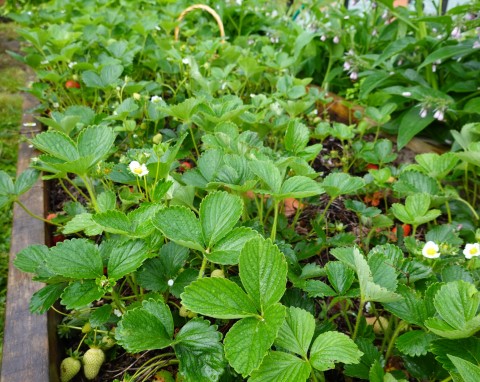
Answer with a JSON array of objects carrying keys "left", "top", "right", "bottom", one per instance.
[{"left": 0, "top": 23, "right": 26, "bottom": 357}]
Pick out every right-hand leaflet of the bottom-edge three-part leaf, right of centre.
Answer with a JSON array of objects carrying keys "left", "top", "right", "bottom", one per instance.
[{"left": 310, "top": 332, "right": 363, "bottom": 371}]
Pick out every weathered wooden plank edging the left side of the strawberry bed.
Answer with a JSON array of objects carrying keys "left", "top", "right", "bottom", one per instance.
[{"left": 0, "top": 94, "right": 58, "bottom": 382}]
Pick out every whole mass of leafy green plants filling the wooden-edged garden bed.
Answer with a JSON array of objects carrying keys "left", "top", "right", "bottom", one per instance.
[{"left": 0, "top": 0, "right": 480, "bottom": 382}]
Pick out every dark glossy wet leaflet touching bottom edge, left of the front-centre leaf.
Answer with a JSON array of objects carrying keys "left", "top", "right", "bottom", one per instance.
[{"left": 173, "top": 318, "right": 225, "bottom": 382}]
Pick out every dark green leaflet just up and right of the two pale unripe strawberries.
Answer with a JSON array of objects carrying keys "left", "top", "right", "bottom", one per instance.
[{"left": 115, "top": 300, "right": 173, "bottom": 353}]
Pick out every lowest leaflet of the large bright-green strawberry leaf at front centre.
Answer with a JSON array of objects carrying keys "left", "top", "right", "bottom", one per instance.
[{"left": 223, "top": 303, "right": 285, "bottom": 377}]
